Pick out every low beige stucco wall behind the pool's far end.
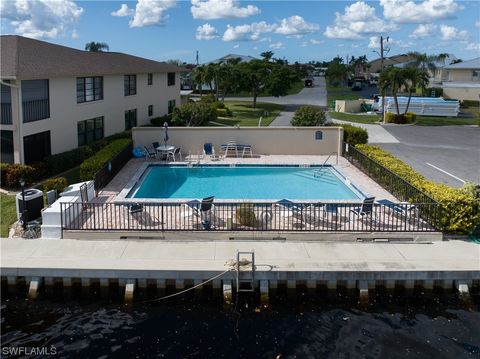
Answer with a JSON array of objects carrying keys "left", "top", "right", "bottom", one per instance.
[{"left": 132, "top": 127, "right": 343, "bottom": 155}]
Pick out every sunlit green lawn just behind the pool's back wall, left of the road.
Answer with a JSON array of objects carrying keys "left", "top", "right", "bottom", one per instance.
[{"left": 215, "top": 101, "right": 283, "bottom": 127}]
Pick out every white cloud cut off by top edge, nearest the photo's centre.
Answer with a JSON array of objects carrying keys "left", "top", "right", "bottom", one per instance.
[{"left": 190, "top": 0, "right": 260, "bottom": 20}]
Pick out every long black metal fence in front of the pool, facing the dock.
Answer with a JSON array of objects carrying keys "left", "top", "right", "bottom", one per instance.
[{"left": 60, "top": 202, "right": 438, "bottom": 232}]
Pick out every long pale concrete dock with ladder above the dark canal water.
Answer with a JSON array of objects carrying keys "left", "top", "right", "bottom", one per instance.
[{"left": 1, "top": 239, "right": 480, "bottom": 301}]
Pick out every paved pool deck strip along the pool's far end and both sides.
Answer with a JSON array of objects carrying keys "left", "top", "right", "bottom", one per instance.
[{"left": 93, "top": 155, "right": 398, "bottom": 203}]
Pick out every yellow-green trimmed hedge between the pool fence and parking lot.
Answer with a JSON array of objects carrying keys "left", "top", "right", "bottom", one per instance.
[{"left": 356, "top": 145, "right": 480, "bottom": 234}]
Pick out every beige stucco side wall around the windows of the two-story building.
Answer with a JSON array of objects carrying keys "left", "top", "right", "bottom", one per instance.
[{"left": 17, "top": 73, "right": 180, "bottom": 158}]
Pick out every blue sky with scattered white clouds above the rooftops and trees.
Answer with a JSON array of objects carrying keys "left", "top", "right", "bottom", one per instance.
[{"left": 0, "top": 0, "right": 480, "bottom": 63}]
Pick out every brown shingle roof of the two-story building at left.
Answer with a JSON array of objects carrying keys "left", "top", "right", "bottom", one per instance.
[{"left": 0, "top": 35, "right": 184, "bottom": 79}]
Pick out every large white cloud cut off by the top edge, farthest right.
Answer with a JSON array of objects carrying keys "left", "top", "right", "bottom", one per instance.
[{"left": 380, "top": 0, "right": 463, "bottom": 24}]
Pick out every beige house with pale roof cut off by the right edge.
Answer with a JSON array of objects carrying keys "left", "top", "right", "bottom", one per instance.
[{"left": 442, "top": 57, "right": 480, "bottom": 101}]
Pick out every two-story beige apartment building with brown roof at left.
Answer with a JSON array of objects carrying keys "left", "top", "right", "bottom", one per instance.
[{"left": 0, "top": 35, "right": 184, "bottom": 163}]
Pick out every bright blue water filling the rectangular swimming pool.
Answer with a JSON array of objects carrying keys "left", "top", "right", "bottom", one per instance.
[{"left": 128, "top": 166, "right": 360, "bottom": 200}]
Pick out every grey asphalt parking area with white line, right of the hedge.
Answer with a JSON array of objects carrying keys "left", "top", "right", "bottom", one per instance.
[{"left": 378, "top": 124, "right": 480, "bottom": 187}]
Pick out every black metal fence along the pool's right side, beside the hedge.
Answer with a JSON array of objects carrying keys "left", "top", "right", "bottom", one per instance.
[{"left": 344, "top": 143, "right": 440, "bottom": 228}]
